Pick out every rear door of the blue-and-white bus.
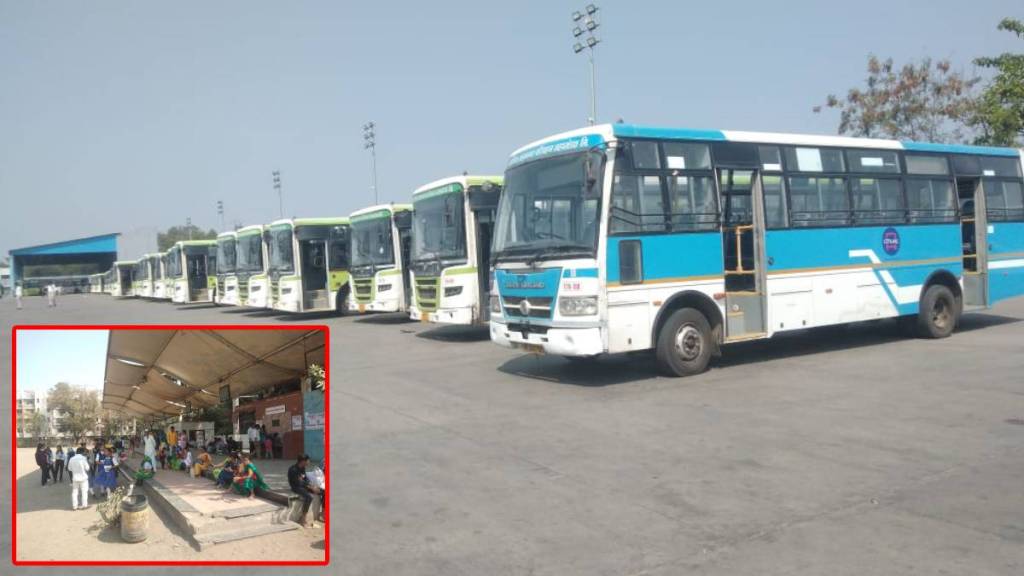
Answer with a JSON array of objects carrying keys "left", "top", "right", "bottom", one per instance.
[{"left": 956, "top": 177, "right": 988, "bottom": 308}]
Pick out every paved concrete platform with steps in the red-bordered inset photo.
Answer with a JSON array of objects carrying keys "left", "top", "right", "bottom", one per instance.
[{"left": 121, "top": 454, "right": 300, "bottom": 549}]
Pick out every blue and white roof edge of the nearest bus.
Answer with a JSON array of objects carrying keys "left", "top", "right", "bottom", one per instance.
[{"left": 509, "top": 124, "right": 1021, "bottom": 165}]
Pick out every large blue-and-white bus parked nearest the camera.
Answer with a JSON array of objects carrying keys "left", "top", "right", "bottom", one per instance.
[{"left": 490, "top": 124, "right": 1024, "bottom": 375}]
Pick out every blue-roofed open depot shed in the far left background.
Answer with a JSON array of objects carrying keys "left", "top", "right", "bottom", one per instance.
[{"left": 6, "top": 233, "right": 121, "bottom": 289}]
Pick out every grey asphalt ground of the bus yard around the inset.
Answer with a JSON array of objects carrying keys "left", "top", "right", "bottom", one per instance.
[{"left": 0, "top": 296, "right": 1024, "bottom": 576}]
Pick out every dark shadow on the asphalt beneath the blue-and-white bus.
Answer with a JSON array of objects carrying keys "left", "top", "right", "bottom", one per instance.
[{"left": 493, "top": 314, "right": 1021, "bottom": 386}]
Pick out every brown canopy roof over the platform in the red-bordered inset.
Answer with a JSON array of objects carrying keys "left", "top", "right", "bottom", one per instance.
[{"left": 102, "top": 326, "right": 326, "bottom": 449}]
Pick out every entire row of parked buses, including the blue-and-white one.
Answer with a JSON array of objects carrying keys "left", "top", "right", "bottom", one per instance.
[{"left": 88, "top": 124, "right": 1024, "bottom": 375}]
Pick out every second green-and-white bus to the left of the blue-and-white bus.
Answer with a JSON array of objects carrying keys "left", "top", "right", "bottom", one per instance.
[{"left": 348, "top": 204, "right": 413, "bottom": 314}]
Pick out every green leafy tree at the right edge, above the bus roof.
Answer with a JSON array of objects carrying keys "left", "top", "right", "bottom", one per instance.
[{"left": 973, "top": 18, "right": 1024, "bottom": 147}]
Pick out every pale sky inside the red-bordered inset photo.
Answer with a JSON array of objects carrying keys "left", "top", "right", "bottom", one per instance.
[{"left": 17, "top": 330, "right": 109, "bottom": 394}]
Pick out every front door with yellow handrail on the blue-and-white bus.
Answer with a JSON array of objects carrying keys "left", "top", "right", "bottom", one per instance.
[{"left": 718, "top": 167, "right": 766, "bottom": 341}]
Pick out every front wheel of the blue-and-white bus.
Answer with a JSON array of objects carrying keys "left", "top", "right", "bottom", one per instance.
[{"left": 655, "top": 308, "right": 715, "bottom": 376}]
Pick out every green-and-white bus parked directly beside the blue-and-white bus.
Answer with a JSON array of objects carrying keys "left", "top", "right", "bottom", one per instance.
[{"left": 409, "top": 175, "right": 502, "bottom": 324}]
